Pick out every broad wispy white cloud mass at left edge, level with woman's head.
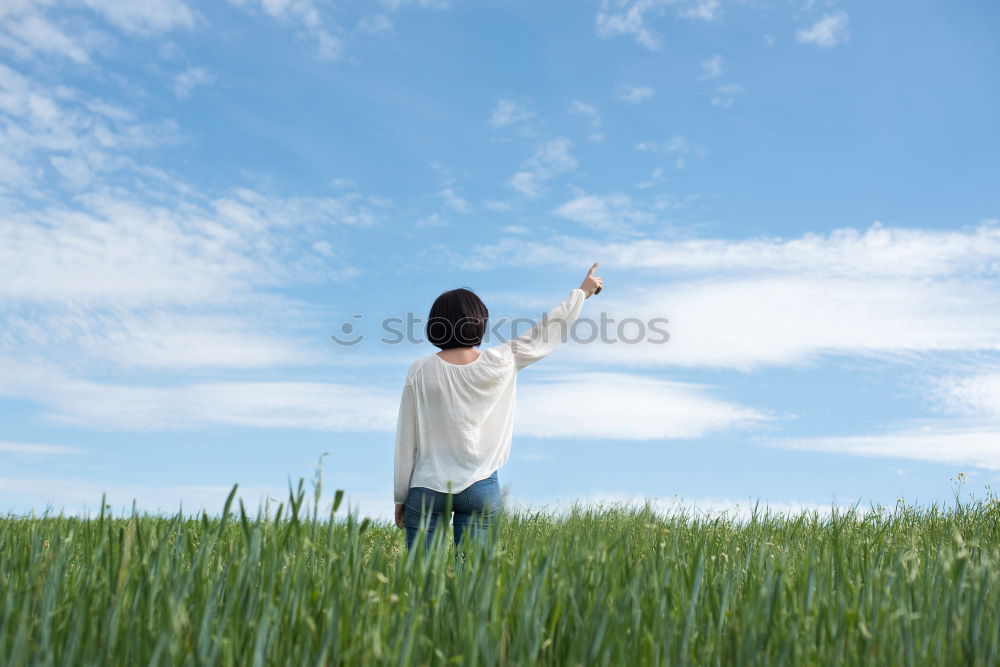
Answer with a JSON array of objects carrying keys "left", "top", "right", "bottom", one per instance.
[{"left": 0, "top": 177, "right": 375, "bottom": 378}]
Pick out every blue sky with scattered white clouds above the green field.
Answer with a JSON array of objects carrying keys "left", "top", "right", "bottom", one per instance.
[{"left": 0, "top": 0, "right": 1000, "bottom": 517}]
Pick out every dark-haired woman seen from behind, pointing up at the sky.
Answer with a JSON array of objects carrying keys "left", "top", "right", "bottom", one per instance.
[{"left": 394, "top": 263, "right": 604, "bottom": 549}]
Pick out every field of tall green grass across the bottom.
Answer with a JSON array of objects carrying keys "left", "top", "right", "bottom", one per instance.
[{"left": 0, "top": 485, "right": 1000, "bottom": 666}]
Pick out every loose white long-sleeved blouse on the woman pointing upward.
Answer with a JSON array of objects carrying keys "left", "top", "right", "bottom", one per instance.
[{"left": 393, "top": 288, "right": 587, "bottom": 503}]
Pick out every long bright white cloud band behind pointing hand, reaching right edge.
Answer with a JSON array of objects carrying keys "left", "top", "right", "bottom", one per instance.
[{"left": 458, "top": 223, "right": 1000, "bottom": 370}]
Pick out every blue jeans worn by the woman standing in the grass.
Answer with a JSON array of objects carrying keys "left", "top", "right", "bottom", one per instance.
[{"left": 403, "top": 471, "right": 500, "bottom": 549}]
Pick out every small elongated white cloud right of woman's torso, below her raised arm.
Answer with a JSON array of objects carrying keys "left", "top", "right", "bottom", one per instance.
[{"left": 515, "top": 373, "right": 770, "bottom": 440}]
